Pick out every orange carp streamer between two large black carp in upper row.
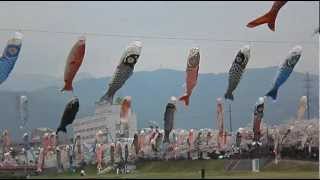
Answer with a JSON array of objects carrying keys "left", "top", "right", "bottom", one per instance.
[{"left": 179, "top": 48, "right": 200, "bottom": 106}]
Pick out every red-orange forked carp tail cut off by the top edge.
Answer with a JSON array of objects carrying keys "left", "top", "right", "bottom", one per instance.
[{"left": 247, "top": 1, "right": 287, "bottom": 31}]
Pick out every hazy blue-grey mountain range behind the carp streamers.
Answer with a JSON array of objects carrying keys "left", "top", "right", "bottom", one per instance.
[{"left": 0, "top": 67, "right": 319, "bottom": 139}]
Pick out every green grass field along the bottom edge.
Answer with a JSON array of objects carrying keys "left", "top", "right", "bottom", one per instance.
[{"left": 32, "top": 160, "right": 319, "bottom": 179}]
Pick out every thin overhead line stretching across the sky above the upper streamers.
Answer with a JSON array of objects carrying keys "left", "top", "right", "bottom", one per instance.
[{"left": 0, "top": 28, "right": 317, "bottom": 45}]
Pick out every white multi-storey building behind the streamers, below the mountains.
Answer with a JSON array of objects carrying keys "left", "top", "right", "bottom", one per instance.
[{"left": 72, "top": 103, "right": 137, "bottom": 144}]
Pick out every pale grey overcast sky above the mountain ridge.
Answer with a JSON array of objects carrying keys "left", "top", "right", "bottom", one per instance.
[{"left": 0, "top": 1, "right": 319, "bottom": 77}]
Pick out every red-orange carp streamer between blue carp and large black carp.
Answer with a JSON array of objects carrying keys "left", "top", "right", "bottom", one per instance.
[{"left": 61, "top": 36, "right": 86, "bottom": 91}]
